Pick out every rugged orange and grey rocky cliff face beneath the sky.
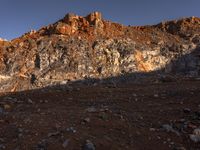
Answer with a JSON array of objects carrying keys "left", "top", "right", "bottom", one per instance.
[{"left": 0, "top": 12, "right": 200, "bottom": 92}]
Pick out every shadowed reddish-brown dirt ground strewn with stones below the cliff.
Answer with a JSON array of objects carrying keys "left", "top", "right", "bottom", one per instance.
[{"left": 0, "top": 81, "right": 200, "bottom": 150}]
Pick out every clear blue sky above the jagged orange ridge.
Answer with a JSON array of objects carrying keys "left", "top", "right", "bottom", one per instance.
[{"left": 0, "top": 0, "right": 200, "bottom": 40}]
